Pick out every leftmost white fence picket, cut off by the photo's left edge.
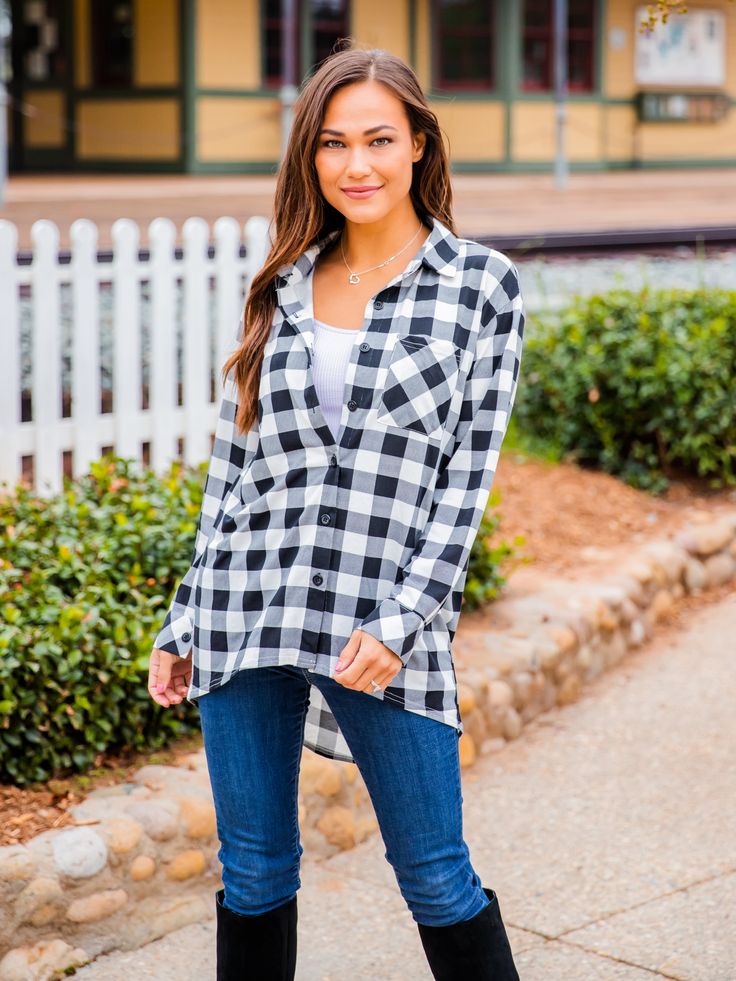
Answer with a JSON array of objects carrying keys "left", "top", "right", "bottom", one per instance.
[{"left": 0, "top": 220, "right": 21, "bottom": 483}]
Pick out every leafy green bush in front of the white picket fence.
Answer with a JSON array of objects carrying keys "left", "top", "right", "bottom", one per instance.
[{"left": 0, "top": 457, "right": 204, "bottom": 785}]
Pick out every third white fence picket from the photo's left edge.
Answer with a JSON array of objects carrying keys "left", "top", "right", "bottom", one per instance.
[{"left": 69, "top": 218, "right": 101, "bottom": 477}]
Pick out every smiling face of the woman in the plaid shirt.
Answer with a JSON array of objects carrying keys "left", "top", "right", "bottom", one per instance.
[{"left": 314, "top": 81, "right": 425, "bottom": 223}]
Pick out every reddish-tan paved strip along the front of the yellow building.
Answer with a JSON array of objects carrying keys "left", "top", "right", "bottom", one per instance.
[{"left": 0, "top": 167, "right": 736, "bottom": 249}]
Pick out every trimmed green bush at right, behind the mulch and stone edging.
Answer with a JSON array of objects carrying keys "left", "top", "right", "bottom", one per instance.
[{"left": 514, "top": 289, "right": 736, "bottom": 492}]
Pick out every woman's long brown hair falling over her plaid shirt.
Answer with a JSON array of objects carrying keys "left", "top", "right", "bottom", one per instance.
[{"left": 222, "top": 38, "right": 455, "bottom": 433}]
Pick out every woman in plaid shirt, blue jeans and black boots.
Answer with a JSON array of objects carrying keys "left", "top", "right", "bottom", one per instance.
[{"left": 149, "top": 42, "right": 524, "bottom": 981}]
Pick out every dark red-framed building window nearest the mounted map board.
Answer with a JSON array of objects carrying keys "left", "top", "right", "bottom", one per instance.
[{"left": 521, "top": 0, "right": 596, "bottom": 92}]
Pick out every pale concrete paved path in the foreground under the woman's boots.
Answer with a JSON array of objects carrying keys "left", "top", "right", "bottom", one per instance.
[{"left": 70, "top": 595, "right": 736, "bottom": 981}]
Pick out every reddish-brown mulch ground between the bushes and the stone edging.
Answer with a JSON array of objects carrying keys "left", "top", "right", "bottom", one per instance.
[{"left": 0, "top": 451, "right": 736, "bottom": 845}]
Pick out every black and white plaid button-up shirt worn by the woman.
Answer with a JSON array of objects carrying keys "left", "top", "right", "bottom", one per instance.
[{"left": 154, "top": 219, "right": 524, "bottom": 761}]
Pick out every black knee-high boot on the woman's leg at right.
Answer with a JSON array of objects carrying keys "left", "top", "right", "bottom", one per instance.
[{"left": 417, "top": 889, "right": 519, "bottom": 981}]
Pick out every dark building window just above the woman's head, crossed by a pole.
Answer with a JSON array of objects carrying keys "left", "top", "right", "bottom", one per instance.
[{"left": 263, "top": 0, "right": 350, "bottom": 88}]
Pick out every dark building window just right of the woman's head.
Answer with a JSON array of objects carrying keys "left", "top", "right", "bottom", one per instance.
[{"left": 433, "top": 0, "right": 496, "bottom": 91}]
